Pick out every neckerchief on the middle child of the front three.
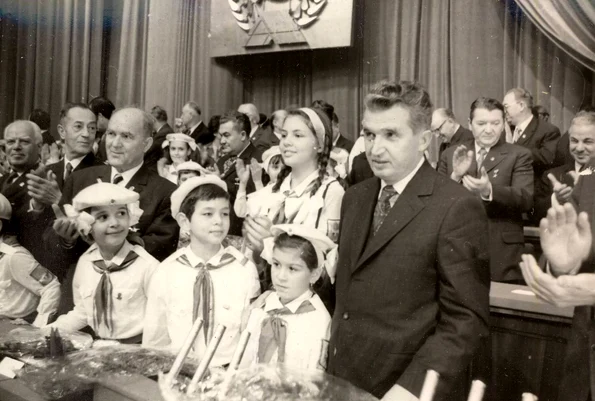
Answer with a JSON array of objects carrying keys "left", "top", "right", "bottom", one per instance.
[{"left": 177, "top": 253, "right": 235, "bottom": 344}]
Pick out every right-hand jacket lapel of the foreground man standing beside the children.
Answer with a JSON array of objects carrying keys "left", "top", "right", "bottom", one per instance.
[{"left": 354, "top": 162, "right": 436, "bottom": 271}]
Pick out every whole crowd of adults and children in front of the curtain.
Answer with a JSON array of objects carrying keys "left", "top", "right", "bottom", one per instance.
[{"left": 0, "top": 81, "right": 595, "bottom": 400}]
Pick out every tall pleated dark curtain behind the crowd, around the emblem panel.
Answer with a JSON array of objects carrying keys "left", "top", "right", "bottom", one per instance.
[{"left": 0, "top": 0, "right": 595, "bottom": 158}]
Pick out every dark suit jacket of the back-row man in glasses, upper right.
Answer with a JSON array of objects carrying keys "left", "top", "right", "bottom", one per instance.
[{"left": 515, "top": 116, "right": 560, "bottom": 177}]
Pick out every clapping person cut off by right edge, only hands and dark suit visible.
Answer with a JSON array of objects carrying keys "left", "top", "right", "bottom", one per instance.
[{"left": 521, "top": 112, "right": 595, "bottom": 401}]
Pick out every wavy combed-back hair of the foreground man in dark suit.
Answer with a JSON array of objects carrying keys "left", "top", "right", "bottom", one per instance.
[{"left": 364, "top": 81, "right": 433, "bottom": 133}]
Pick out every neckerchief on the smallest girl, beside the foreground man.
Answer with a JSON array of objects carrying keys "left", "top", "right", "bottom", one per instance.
[{"left": 258, "top": 300, "right": 316, "bottom": 363}]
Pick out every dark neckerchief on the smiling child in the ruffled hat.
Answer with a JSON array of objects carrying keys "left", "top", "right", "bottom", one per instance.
[{"left": 93, "top": 251, "right": 138, "bottom": 334}]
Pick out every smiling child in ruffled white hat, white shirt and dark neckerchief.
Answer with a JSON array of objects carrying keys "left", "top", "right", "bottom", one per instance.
[{"left": 50, "top": 182, "right": 159, "bottom": 343}]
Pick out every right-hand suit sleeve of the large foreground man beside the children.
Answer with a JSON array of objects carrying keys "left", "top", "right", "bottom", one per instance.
[{"left": 397, "top": 196, "right": 490, "bottom": 396}]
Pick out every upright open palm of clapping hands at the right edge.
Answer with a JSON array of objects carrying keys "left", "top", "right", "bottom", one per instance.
[{"left": 539, "top": 203, "right": 592, "bottom": 274}]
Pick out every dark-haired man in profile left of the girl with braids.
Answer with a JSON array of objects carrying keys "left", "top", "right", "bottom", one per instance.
[{"left": 217, "top": 111, "right": 262, "bottom": 235}]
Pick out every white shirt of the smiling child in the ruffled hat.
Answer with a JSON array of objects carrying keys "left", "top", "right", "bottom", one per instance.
[{"left": 50, "top": 241, "right": 159, "bottom": 339}]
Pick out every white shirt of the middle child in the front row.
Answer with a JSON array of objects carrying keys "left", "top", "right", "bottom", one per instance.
[{"left": 143, "top": 247, "right": 260, "bottom": 366}]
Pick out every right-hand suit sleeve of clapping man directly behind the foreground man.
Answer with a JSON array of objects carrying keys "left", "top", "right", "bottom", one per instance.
[{"left": 486, "top": 149, "right": 533, "bottom": 215}]
